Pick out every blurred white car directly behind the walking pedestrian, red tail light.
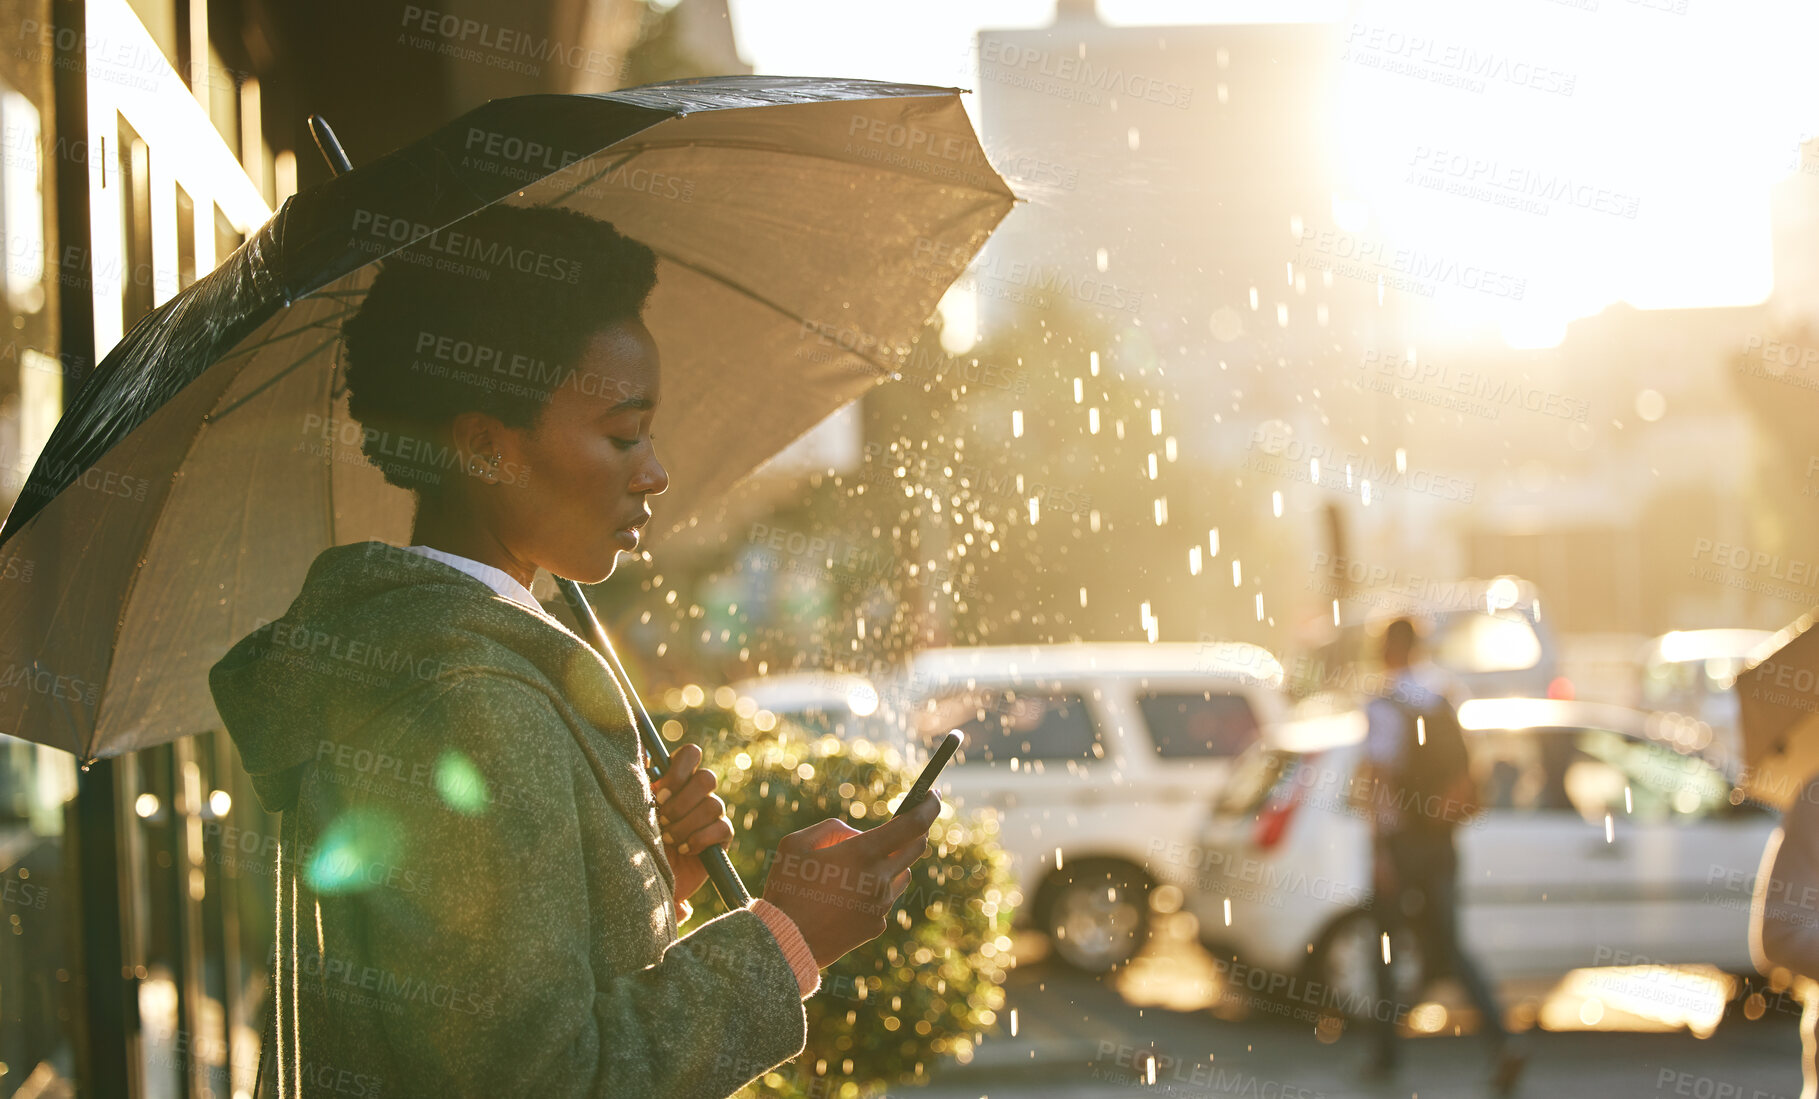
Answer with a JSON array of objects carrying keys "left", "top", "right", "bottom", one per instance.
[{"left": 1182, "top": 699, "right": 1775, "bottom": 1004}]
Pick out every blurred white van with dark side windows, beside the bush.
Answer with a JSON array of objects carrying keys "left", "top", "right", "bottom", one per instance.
[{"left": 737, "top": 642, "right": 1284, "bottom": 972}]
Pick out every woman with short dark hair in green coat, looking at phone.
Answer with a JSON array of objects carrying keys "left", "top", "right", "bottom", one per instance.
[{"left": 209, "top": 207, "right": 940, "bottom": 1097}]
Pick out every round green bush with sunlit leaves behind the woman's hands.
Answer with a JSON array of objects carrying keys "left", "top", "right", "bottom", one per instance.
[{"left": 653, "top": 701, "right": 1013, "bottom": 1099}]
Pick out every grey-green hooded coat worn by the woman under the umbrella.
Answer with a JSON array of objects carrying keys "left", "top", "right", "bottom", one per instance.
[{"left": 209, "top": 542, "right": 808, "bottom": 1099}]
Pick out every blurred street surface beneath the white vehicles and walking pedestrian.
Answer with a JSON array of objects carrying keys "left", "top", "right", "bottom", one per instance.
[{"left": 909, "top": 921, "right": 1801, "bottom": 1099}]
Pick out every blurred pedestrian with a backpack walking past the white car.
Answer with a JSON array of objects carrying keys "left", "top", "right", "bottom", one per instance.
[{"left": 1357, "top": 619, "right": 1526, "bottom": 1095}]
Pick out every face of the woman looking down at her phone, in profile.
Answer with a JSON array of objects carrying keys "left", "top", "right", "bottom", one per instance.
[{"left": 487, "top": 320, "right": 669, "bottom": 584}]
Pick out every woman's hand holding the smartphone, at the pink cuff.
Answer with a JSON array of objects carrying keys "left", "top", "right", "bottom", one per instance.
[{"left": 764, "top": 791, "right": 940, "bottom": 968}]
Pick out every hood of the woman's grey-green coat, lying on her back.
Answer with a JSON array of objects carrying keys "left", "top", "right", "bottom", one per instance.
[{"left": 209, "top": 542, "right": 573, "bottom": 812}]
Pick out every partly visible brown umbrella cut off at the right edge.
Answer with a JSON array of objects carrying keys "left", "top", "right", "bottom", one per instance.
[{"left": 1735, "top": 613, "right": 1819, "bottom": 808}]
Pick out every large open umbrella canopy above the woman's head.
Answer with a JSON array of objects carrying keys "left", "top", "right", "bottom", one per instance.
[{"left": 0, "top": 76, "right": 1015, "bottom": 759}]
